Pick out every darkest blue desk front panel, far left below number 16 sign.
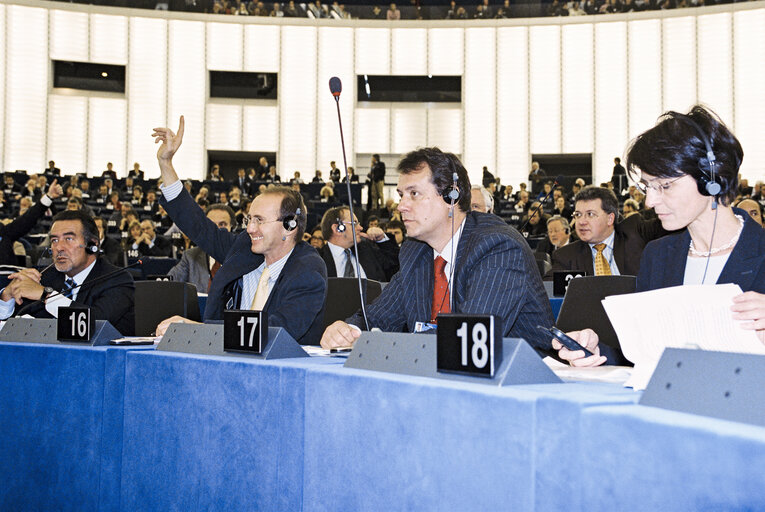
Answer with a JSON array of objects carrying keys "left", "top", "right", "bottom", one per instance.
[{"left": 0, "top": 343, "right": 126, "bottom": 511}]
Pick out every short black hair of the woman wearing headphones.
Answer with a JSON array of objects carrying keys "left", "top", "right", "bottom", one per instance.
[{"left": 627, "top": 105, "right": 744, "bottom": 205}]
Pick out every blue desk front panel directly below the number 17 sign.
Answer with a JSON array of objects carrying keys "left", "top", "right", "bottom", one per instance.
[{"left": 121, "top": 351, "right": 338, "bottom": 511}]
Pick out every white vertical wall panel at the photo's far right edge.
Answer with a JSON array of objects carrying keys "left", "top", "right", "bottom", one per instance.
[{"left": 733, "top": 9, "right": 765, "bottom": 184}]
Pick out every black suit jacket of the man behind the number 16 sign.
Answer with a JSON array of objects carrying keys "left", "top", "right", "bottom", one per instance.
[{"left": 19, "top": 258, "right": 135, "bottom": 336}]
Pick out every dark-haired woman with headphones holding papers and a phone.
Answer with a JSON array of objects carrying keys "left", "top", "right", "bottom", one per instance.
[{"left": 553, "top": 105, "right": 765, "bottom": 366}]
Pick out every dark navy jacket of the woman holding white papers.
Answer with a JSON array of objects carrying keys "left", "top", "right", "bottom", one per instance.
[{"left": 637, "top": 208, "right": 765, "bottom": 293}]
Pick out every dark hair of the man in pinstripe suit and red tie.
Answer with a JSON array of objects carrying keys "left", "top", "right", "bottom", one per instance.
[{"left": 398, "top": 147, "right": 471, "bottom": 212}]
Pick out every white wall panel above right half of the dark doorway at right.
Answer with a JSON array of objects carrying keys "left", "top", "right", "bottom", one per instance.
[{"left": 561, "top": 23, "right": 594, "bottom": 153}]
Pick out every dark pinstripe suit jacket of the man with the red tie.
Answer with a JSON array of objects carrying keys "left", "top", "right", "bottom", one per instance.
[{"left": 347, "top": 212, "right": 553, "bottom": 349}]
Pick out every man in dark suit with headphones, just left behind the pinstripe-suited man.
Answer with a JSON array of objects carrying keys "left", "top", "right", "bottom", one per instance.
[{"left": 319, "top": 206, "right": 398, "bottom": 282}]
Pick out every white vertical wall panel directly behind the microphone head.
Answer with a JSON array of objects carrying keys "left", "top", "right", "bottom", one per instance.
[{"left": 314, "top": 27, "right": 356, "bottom": 177}]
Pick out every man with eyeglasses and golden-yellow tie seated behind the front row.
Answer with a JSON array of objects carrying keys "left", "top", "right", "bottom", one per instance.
[{"left": 552, "top": 185, "right": 667, "bottom": 276}]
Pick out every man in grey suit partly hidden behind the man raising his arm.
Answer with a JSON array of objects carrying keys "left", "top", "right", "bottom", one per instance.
[{"left": 168, "top": 204, "right": 236, "bottom": 293}]
